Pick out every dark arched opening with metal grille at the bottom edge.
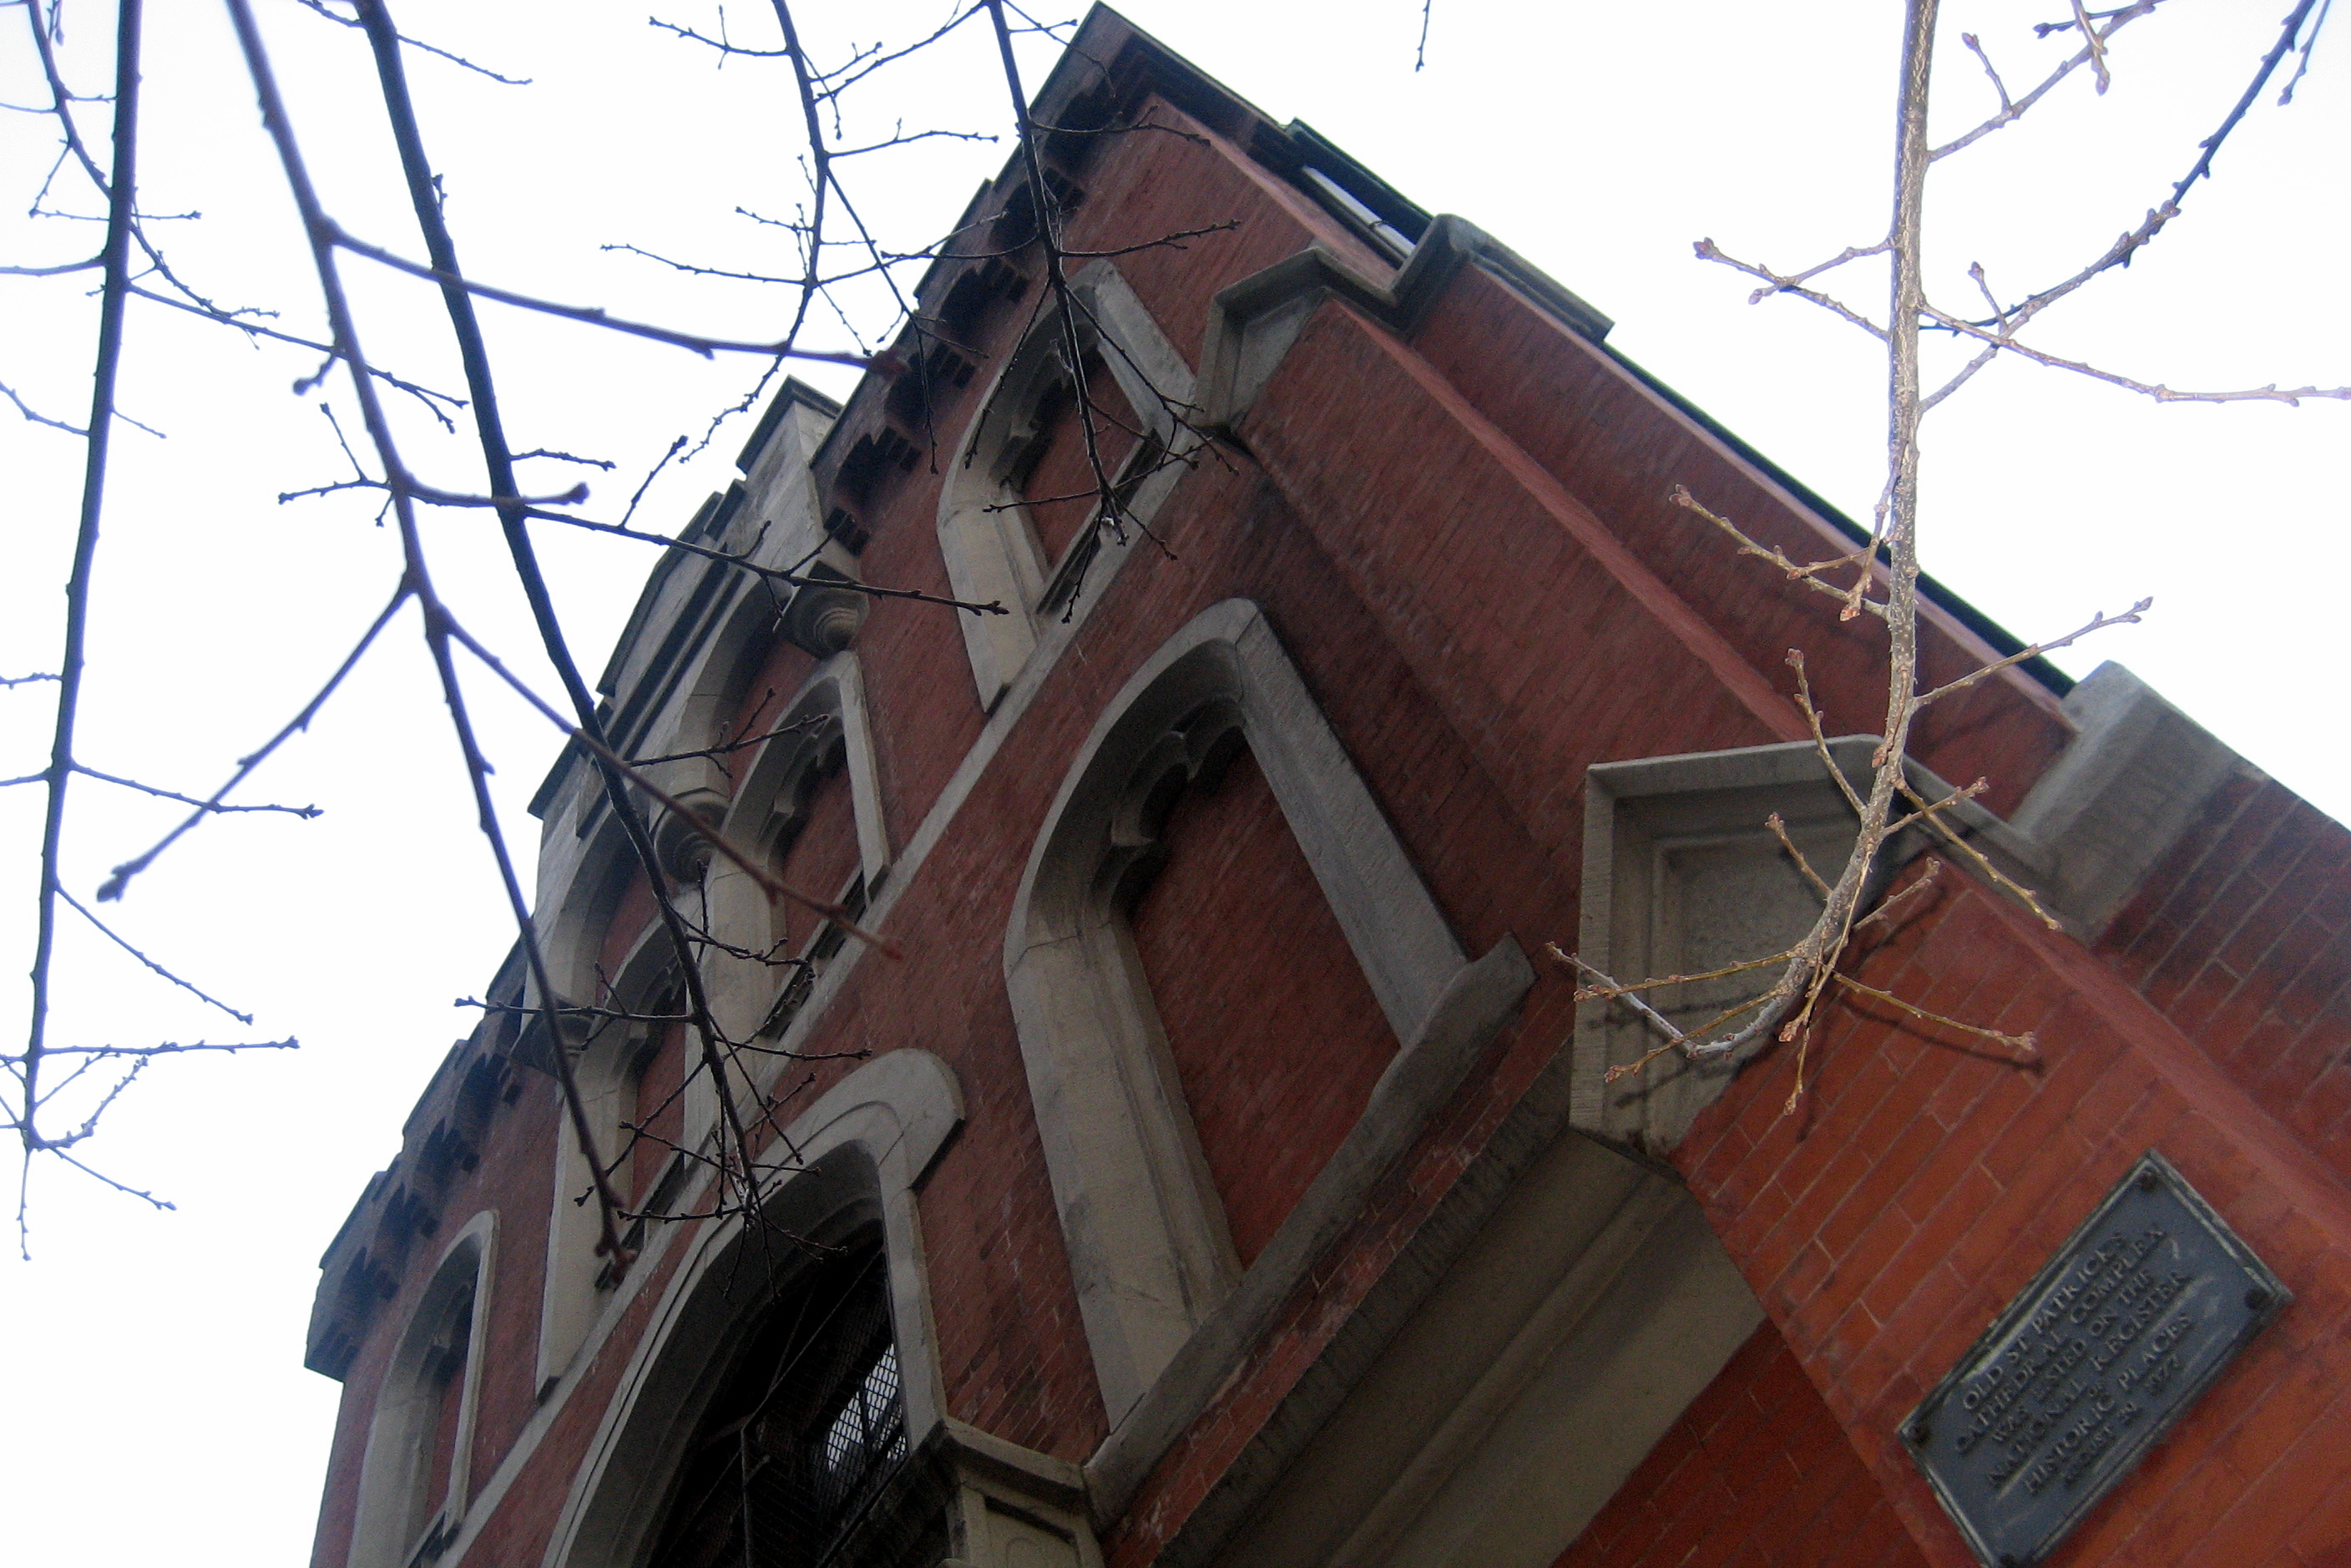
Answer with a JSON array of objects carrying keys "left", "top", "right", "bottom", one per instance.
[{"left": 651, "top": 1232, "right": 945, "bottom": 1568}]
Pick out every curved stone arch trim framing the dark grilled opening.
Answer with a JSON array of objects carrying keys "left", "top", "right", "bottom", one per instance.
[{"left": 543, "top": 1046, "right": 964, "bottom": 1568}]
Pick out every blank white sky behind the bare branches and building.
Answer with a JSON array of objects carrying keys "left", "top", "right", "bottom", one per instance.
[{"left": 0, "top": 0, "right": 2351, "bottom": 1565}]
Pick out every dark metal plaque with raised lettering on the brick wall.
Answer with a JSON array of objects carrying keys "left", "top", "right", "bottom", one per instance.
[{"left": 1902, "top": 1150, "right": 2293, "bottom": 1568}]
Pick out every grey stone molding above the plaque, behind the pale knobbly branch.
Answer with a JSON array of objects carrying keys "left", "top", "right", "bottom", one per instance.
[{"left": 1570, "top": 663, "right": 2247, "bottom": 1156}]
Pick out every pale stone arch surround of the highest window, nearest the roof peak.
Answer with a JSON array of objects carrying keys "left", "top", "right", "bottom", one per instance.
[{"left": 938, "top": 261, "right": 1192, "bottom": 707}]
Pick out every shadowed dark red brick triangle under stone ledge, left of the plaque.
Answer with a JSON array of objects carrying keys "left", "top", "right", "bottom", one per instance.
[{"left": 1554, "top": 1323, "right": 1925, "bottom": 1568}]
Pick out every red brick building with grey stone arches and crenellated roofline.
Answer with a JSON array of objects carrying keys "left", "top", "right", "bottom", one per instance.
[{"left": 308, "top": 9, "right": 2351, "bottom": 1568}]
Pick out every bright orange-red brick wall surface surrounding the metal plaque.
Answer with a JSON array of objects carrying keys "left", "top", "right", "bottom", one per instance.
[{"left": 1676, "top": 882, "right": 2351, "bottom": 1568}]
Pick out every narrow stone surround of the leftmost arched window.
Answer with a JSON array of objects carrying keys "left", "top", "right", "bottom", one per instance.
[{"left": 348, "top": 1208, "right": 498, "bottom": 1568}]
